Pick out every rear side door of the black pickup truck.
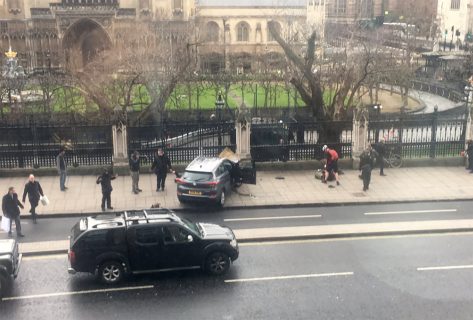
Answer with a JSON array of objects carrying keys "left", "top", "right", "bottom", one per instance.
[{"left": 127, "top": 225, "right": 162, "bottom": 272}]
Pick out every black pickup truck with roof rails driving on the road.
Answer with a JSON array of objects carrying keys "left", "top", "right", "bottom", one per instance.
[{"left": 68, "top": 209, "right": 239, "bottom": 284}]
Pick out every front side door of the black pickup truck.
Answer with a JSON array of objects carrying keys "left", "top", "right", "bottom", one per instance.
[{"left": 160, "top": 224, "right": 201, "bottom": 269}]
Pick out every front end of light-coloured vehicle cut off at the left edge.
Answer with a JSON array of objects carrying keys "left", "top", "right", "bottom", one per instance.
[{"left": 0, "top": 239, "right": 22, "bottom": 298}]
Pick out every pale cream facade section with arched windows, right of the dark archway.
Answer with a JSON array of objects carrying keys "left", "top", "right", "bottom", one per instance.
[{"left": 196, "top": 0, "right": 308, "bottom": 73}]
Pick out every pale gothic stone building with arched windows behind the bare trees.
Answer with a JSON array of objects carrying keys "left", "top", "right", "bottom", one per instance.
[{"left": 0, "top": 0, "right": 382, "bottom": 72}]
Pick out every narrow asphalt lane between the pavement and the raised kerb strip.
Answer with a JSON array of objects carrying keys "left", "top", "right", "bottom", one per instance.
[{"left": 0, "top": 201, "right": 473, "bottom": 242}]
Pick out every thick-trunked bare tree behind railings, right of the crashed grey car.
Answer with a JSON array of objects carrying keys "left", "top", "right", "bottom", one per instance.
[{"left": 269, "top": 22, "right": 377, "bottom": 141}]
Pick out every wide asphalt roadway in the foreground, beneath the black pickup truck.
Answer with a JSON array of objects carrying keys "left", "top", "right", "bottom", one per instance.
[{"left": 0, "top": 233, "right": 473, "bottom": 320}]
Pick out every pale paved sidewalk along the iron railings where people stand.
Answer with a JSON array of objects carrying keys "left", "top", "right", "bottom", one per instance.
[{"left": 0, "top": 167, "right": 473, "bottom": 217}]
